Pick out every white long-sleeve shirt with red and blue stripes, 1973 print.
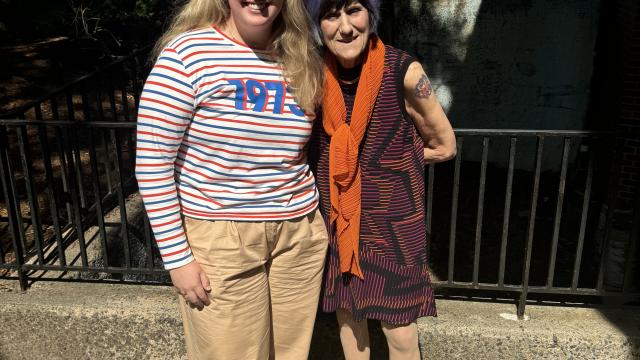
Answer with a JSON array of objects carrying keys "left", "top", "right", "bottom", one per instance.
[{"left": 136, "top": 27, "right": 318, "bottom": 269}]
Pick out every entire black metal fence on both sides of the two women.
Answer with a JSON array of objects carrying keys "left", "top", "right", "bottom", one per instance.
[{"left": 0, "top": 47, "right": 638, "bottom": 314}]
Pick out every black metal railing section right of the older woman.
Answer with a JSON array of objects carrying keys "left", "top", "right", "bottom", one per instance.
[{"left": 427, "top": 129, "right": 638, "bottom": 315}]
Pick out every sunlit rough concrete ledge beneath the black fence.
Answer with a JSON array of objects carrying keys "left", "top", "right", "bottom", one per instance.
[{"left": 0, "top": 281, "right": 640, "bottom": 360}]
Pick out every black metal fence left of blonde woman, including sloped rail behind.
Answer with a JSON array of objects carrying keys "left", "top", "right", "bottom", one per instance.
[{"left": 0, "top": 47, "right": 163, "bottom": 288}]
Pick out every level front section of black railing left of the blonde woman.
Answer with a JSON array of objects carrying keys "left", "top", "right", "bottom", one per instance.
[{"left": 0, "top": 120, "right": 168, "bottom": 285}]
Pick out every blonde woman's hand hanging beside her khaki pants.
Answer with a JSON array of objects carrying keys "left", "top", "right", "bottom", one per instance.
[{"left": 169, "top": 260, "right": 211, "bottom": 310}]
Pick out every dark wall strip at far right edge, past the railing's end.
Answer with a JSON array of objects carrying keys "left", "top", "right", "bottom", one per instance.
[{"left": 596, "top": 0, "right": 640, "bottom": 289}]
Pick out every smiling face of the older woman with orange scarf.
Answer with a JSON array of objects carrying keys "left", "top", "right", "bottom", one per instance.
[{"left": 320, "top": 1, "right": 370, "bottom": 69}]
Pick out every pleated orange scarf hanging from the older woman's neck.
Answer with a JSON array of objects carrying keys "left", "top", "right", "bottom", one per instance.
[{"left": 322, "top": 35, "right": 384, "bottom": 279}]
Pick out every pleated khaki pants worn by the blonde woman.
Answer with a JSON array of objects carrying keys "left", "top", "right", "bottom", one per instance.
[{"left": 179, "top": 210, "right": 328, "bottom": 360}]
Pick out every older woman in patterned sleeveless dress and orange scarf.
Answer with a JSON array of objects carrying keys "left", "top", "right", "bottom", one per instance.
[{"left": 307, "top": 0, "right": 456, "bottom": 359}]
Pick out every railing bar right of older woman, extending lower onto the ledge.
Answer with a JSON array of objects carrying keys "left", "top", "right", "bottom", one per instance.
[{"left": 518, "top": 136, "right": 544, "bottom": 317}]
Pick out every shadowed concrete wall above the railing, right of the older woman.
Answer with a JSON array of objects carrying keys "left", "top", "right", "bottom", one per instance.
[{"left": 382, "top": 0, "right": 600, "bottom": 129}]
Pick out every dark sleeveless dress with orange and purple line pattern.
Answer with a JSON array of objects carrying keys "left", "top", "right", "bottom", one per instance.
[{"left": 309, "top": 46, "right": 436, "bottom": 325}]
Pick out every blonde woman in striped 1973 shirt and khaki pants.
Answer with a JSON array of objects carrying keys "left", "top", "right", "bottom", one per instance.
[{"left": 136, "top": 0, "right": 328, "bottom": 359}]
